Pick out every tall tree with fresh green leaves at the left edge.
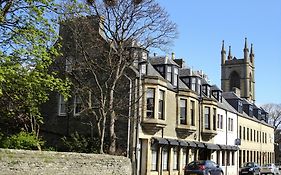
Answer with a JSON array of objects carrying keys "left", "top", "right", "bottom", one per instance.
[{"left": 0, "top": 0, "right": 69, "bottom": 143}]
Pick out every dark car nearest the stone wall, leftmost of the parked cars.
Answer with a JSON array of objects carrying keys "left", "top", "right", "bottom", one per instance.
[{"left": 184, "top": 160, "right": 223, "bottom": 175}]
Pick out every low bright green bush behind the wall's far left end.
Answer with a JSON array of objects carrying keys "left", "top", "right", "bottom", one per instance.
[{"left": 0, "top": 131, "right": 44, "bottom": 150}]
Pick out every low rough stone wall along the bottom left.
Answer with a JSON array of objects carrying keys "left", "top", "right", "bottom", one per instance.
[{"left": 0, "top": 149, "right": 131, "bottom": 175}]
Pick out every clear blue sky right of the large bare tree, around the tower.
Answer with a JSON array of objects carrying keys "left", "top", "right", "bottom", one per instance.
[{"left": 155, "top": 0, "right": 281, "bottom": 105}]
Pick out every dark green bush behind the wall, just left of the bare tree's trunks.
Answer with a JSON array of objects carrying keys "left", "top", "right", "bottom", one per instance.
[{"left": 62, "top": 132, "right": 99, "bottom": 153}]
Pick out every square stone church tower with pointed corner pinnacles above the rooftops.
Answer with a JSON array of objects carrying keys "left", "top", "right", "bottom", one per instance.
[{"left": 221, "top": 38, "right": 255, "bottom": 103}]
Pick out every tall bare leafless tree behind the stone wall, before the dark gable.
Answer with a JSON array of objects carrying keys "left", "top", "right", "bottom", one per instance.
[{"left": 59, "top": 0, "right": 177, "bottom": 153}]
